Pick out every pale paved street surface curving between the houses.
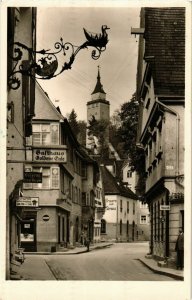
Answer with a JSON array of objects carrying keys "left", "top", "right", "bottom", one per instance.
[{"left": 15, "top": 242, "right": 183, "bottom": 281}]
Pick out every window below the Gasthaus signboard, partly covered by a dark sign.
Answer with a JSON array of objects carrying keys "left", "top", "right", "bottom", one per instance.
[{"left": 24, "top": 166, "right": 59, "bottom": 189}]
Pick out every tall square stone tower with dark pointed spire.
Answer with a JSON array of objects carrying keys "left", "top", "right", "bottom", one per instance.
[{"left": 86, "top": 66, "right": 110, "bottom": 148}]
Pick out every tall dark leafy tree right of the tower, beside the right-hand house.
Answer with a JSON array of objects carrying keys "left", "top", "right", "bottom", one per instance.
[{"left": 118, "top": 94, "right": 145, "bottom": 193}]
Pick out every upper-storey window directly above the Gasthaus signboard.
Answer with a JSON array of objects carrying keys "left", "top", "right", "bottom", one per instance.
[{"left": 33, "top": 123, "right": 59, "bottom": 145}]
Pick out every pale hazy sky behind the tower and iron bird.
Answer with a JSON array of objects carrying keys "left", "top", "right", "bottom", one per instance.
[{"left": 37, "top": 7, "right": 140, "bottom": 121}]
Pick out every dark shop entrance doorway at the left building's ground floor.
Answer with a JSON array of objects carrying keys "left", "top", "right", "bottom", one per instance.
[{"left": 20, "top": 217, "right": 37, "bottom": 252}]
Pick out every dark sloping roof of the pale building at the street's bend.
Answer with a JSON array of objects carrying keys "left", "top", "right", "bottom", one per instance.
[{"left": 100, "top": 166, "right": 138, "bottom": 200}]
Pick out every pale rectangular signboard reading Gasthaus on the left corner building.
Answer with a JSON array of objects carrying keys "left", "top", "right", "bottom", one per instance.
[{"left": 33, "top": 149, "right": 67, "bottom": 163}]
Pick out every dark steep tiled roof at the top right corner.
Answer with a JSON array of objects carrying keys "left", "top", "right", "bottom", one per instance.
[{"left": 144, "top": 7, "right": 185, "bottom": 96}]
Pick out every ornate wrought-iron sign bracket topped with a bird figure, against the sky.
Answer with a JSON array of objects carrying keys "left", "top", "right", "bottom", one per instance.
[{"left": 8, "top": 25, "right": 109, "bottom": 90}]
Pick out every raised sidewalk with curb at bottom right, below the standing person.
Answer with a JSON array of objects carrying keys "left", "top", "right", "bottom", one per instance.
[{"left": 139, "top": 257, "right": 184, "bottom": 280}]
